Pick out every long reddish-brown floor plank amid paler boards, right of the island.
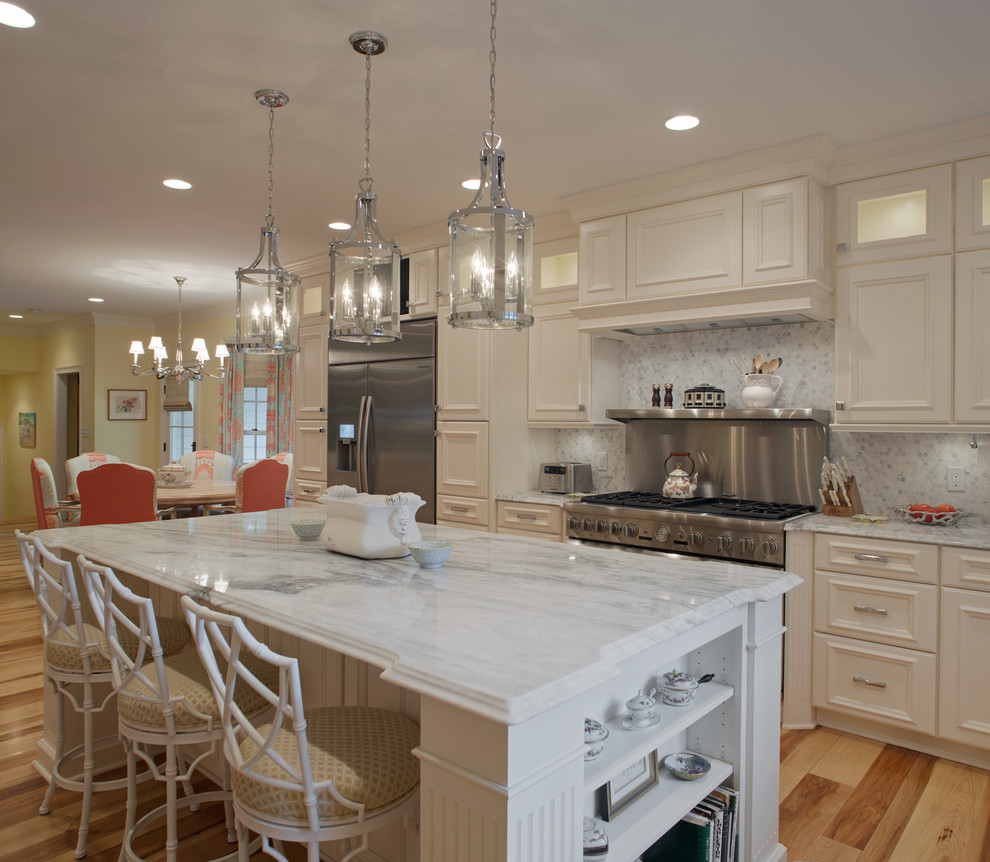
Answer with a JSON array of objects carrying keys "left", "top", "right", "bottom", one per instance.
[{"left": 815, "top": 745, "right": 918, "bottom": 850}]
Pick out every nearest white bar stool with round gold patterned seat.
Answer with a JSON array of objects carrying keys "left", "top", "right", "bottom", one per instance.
[{"left": 182, "top": 596, "right": 419, "bottom": 862}]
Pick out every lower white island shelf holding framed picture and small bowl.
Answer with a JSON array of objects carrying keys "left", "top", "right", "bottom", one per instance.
[{"left": 605, "top": 755, "right": 732, "bottom": 862}]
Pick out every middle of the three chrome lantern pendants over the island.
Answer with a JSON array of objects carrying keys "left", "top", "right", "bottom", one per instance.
[{"left": 330, "top": 30, "right": 402, "bottom": 344}]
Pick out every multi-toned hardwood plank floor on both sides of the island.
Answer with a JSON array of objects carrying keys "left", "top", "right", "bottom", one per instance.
[{"left": 0, "top": 524, "right": 990, "bottom": 862}]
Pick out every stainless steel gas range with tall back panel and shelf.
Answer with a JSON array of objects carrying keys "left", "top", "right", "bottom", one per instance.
[{"left": 564, "top": 408, "right": 828, "bottom": 568}]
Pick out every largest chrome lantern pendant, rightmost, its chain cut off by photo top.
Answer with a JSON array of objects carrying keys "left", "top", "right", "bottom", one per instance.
[{"left": 447, "top": 0, "right": 533, "bottom": 329}]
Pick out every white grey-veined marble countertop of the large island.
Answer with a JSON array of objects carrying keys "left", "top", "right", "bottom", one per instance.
[{"left": 39, "top": 510, "right": 801, "bottom": 724}]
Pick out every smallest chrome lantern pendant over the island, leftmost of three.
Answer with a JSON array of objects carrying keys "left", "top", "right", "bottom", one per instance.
[{"left": 235, "top": 90, "right": 302, "bottom": 354}]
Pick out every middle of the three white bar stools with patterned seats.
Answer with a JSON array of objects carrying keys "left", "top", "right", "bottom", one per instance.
[{"left": 78, "top": 555, "right": 276, "bottom": 862}]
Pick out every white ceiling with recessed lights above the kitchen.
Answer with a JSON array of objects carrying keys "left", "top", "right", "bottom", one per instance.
[{"left": 0, "top": 0, "right": 990, "bottom": 332}]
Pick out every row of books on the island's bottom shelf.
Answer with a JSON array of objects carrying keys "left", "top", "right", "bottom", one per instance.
[{"left": 640, "top": 787, "right": 739, "bottom": 862}]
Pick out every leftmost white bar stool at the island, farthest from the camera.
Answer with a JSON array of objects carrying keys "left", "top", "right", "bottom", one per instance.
[{"left": 14, "top": 530, "right": 188, "bottom": 859}]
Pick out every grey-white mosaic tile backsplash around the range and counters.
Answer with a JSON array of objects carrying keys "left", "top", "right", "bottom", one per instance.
[{"left": 555, "top": 323, "right": 990, "bottom": 519}]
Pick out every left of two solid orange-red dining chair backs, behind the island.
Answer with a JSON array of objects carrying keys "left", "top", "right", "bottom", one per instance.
[{"left": 79, "top": 463, "right": 158, "bottom": 527}]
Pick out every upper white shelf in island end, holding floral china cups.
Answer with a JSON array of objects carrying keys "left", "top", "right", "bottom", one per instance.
[{"left": 584, "top": 682, "right": 735, "bottom": 796}]
